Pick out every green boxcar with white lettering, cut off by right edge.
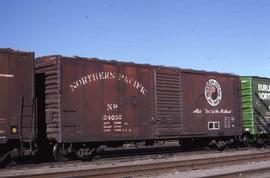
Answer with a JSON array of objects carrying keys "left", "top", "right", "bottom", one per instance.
[{"left": 241, "top": 77, "right": 270, "bottom": 135}]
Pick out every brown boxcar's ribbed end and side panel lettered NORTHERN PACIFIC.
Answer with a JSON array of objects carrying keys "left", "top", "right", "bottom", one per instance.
[{"left": 36, "top": 56, "right": 155, "bottom": 142}]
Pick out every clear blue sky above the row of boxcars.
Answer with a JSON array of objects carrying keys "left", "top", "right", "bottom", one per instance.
[{"left": 0, "top": 0, "right": 270, "bottom": 77}]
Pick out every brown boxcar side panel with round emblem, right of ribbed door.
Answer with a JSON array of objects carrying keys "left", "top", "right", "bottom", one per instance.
[{"left": 181, "top": 71, "right": 241, "bottom": 136}]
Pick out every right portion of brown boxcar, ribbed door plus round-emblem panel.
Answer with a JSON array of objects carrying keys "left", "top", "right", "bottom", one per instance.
[{"left": 154, "top": 68, "right": 242, "bottom": 138}]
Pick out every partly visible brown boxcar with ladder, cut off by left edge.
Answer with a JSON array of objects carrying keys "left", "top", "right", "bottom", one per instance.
[{"left": 0, "top": 49, "right": 36, "bottom": 162}]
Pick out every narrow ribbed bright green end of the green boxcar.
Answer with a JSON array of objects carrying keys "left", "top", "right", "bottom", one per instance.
[{"left": 240, "top": 77, "right": 255, "bottom": 134}]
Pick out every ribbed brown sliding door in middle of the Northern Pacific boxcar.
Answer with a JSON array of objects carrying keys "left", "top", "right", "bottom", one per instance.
[{"left": 156, "top": 71, "right": 181, "bottom": 136}]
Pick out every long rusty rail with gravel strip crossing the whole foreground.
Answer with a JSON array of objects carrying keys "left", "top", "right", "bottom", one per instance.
[{"left": 1, "top": 151, "right": 270, "bottom": 178}]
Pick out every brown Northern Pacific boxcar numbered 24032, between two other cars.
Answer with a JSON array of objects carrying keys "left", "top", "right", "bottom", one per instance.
[{"left": 36, "top": 56, "right": 242, "bottom": 160}]
